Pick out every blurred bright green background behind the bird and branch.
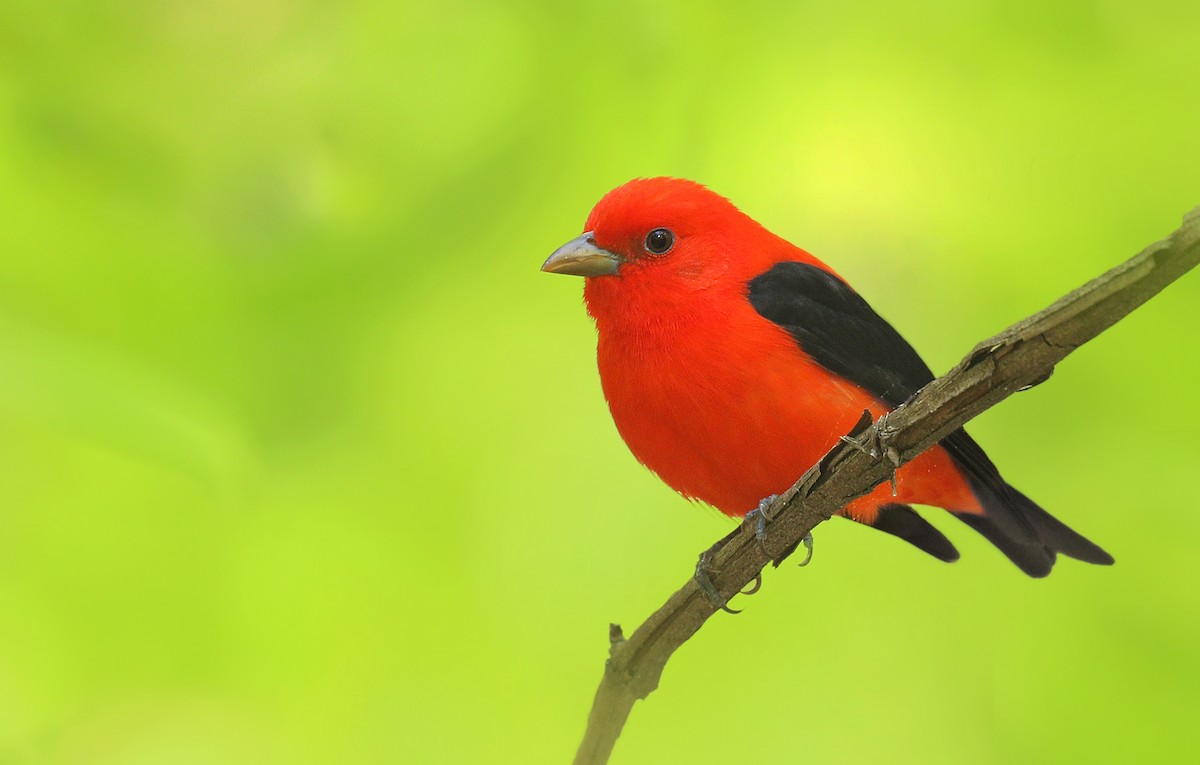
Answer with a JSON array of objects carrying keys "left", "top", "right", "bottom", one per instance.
[{"left": 0, "top": 0, "right": 1200, "bottom": 765}]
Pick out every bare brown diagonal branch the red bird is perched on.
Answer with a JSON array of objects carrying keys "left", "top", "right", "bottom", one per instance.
[{"left": 575, "top": 207, "right": 1200, "bottom": 765}]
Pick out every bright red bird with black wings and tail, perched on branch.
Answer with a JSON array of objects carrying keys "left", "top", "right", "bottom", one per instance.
[{"left": 542, "top": 177, "right": 1112, "bottom": 577}]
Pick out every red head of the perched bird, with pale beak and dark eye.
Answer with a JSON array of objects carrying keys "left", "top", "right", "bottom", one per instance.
[{"left": 541, "top": 177, "right": 782, "bottom": 291}]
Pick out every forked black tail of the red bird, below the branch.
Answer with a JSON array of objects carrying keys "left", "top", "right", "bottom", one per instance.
[{"left": 941, "top": 429, "right": 1112, "bottom": 577}]
